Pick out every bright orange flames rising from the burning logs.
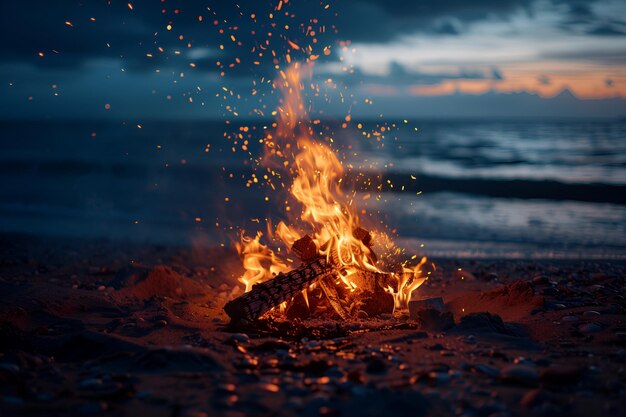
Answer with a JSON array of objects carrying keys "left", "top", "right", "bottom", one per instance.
[{"left": 238, "top": 63, "right": 426, "bottom": 307}]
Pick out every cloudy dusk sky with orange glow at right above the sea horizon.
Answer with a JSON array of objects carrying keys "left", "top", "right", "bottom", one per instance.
[{"left": 0, "top": 0, "right": 626, "bottom": 121}]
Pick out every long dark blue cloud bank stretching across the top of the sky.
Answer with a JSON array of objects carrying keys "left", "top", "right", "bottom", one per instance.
[{"left": 0, "top": 0, "right": 608, "bottom": 73}]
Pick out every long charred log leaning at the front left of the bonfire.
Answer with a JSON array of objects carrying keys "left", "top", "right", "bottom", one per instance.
[{"left": 224, "top": 259, "right": 335, "bottom": 322}]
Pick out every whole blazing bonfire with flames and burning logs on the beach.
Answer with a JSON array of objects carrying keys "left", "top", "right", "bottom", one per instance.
[{"left": 224, "top": 63, "right": 428, "bottom": 321}]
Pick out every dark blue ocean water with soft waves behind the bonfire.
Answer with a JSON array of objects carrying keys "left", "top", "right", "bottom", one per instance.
[{"left": 0, "top": 120, "right": 626, "bottom": 259}]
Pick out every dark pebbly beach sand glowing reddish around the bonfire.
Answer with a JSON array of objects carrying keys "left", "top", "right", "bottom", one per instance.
[{"left": 0, "top": 235, "right": 626, "bottom": 417}]
